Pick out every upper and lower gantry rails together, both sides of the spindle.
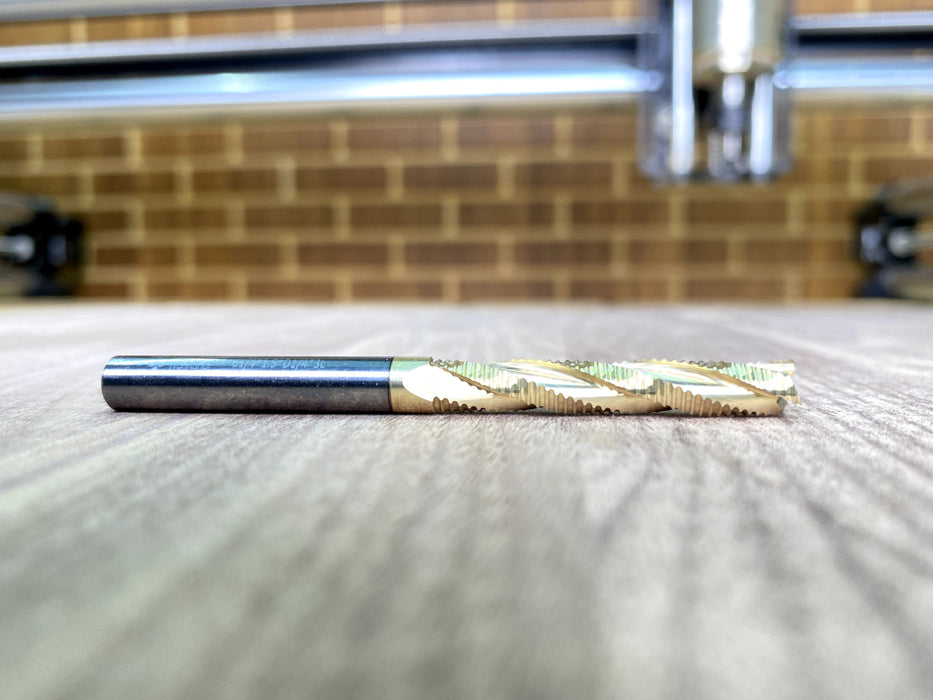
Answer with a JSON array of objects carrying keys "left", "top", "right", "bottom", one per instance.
[{"left": 0, "top": 12, "right": 933, "bottom": 123}]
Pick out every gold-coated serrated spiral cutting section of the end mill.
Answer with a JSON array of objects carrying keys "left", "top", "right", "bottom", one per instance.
[{"left": 392, "top": 358, "right": 799, "bottom": 416}]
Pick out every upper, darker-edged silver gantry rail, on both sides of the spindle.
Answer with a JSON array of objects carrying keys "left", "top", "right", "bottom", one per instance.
[{"left": 0, "top": 8, "right": 933, "bottom": 77}]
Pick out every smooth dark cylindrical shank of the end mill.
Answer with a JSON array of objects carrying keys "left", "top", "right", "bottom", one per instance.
[{"left": 101, "top": 356, "right": 392, "bottom": 413}]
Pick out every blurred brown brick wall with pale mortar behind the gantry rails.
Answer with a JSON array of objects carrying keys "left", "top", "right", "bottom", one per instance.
[{"left": 0, "top": 0, "right": 933, "bottom": 301}]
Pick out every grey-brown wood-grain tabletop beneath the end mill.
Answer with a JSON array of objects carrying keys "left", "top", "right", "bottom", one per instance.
[{"left": 0, "top": 304, "right": 933, "bottom": 699}]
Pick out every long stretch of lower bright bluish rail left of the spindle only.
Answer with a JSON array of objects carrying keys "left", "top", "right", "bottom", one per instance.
[{"left": 0, "top": 52, "right": 649, "bottom": 124}]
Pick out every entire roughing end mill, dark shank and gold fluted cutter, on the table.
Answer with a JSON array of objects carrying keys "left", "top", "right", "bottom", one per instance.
[{"left": 101, "top": 356, "right": 800, "bottom": 416}]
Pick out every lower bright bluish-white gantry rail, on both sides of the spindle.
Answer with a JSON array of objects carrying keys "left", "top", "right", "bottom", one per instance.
[{"left": 0, "top": 51, "right": 933, "bottom": 125}]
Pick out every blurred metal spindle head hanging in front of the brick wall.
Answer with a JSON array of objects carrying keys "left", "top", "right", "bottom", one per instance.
[{"left": 639, "top": 0, "right": 791, "bottom": 181}]
